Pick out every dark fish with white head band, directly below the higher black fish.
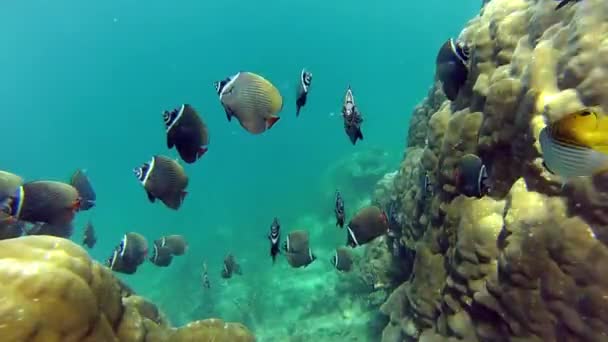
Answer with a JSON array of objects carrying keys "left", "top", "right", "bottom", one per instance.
[{"left": 133, "top": 155, "right": 188, "bottom": 210}]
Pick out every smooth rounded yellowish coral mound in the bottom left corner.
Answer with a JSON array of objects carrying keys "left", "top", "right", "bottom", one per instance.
[{"left": 0, "top": 236, "right": 255, "bottom": 342}]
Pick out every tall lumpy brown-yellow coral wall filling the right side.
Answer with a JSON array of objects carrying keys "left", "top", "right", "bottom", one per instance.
[{"left": 381, "top": 0, "right": 608, "bottom": 342}]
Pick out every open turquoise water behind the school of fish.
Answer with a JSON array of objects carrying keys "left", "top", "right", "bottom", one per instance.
[{"left": 0, "top": 0, "right": 480, "bottom": 335}]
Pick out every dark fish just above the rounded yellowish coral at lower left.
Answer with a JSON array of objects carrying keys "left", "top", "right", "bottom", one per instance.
[{"left": 106, "top": 232, "right": 148, "bottom": 274}]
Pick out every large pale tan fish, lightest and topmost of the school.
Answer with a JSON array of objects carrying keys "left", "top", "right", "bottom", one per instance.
[{"left": 214, "top": 71, "right": 283, "bottom": 134}]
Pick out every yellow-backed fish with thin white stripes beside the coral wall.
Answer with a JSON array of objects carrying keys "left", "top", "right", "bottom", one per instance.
[{"left": 539, "top": 108, "right": 608, "bottom": 181}]
